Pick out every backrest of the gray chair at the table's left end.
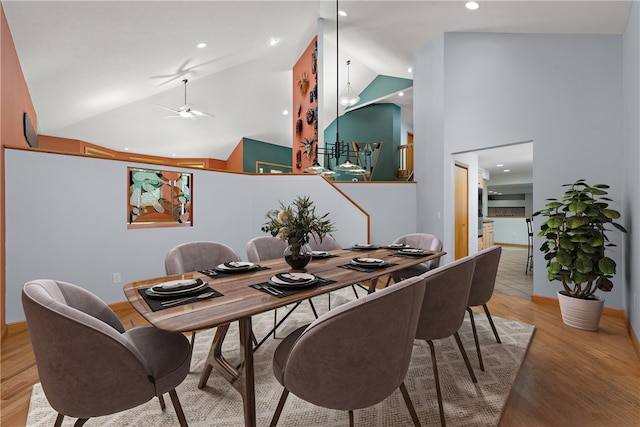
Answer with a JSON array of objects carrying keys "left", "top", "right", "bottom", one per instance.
[{"left": 22, "top": 280, "right": 155, "bottom": 417}]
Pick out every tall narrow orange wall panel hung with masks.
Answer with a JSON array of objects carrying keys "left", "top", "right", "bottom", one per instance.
[{"left": 291, "top": 36, "right": 320, "bottom": 173}]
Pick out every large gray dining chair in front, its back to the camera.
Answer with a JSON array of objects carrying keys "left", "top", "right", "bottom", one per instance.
[{"left": 271, "top": 277, "right": 425, "bottom": 426}]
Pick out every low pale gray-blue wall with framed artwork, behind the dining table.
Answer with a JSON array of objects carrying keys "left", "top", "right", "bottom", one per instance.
[{"left": 4, "top": 149, "right": 416, "bottom": 323}]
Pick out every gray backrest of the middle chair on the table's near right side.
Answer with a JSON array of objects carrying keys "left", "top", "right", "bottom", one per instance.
[{"left": 416, "top": 256, "right": 475, "bottom": 340}]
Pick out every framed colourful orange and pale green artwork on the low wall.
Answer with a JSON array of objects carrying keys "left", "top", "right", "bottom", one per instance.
[{"left": 127, "top": 168, "right": 193, "bottom": 228}]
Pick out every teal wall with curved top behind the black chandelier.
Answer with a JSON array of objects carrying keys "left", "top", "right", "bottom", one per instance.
[{"left": 324, "top": 104, "right": 401, "bottom": 181}]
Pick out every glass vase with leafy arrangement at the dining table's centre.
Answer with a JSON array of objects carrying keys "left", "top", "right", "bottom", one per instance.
[{"left": 261, "top": 196, "right": 334, "bottom": 269}]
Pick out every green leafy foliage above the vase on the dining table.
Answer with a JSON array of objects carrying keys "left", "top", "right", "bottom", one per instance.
[{"left": 261, "top": 196, "right": 335, "bottom": 248}]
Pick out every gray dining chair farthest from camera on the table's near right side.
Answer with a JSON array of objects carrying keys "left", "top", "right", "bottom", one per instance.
[{"left": 467, "top": 246, "right": 502, "bottom": 371}]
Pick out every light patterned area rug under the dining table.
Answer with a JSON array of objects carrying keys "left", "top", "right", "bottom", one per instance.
[{"left": 27, "top": 289, "right": 535, "bottom": 427}]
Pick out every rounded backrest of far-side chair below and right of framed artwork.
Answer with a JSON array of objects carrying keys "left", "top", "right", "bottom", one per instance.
[{"left": 164, "top": 242, "right": 241, "bottom": 275}]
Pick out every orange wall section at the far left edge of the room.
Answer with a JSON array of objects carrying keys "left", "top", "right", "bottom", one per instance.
[{"left": 0, "top": 3, "right": 38, "bottom": 337}]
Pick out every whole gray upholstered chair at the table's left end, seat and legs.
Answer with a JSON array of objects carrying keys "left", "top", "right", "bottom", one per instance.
[{"left": 22, "top": 280, "right": 191, "bottom": 426}]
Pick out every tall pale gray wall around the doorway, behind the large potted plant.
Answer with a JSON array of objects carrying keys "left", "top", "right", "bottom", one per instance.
[{"left": 414, "top": 33, "right": 637, "bottom": 308}]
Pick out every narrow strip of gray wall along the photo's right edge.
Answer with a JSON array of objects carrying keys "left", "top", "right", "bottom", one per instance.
[{"left": 621, "top": 1, "right": 640, "bottom": 342}]
